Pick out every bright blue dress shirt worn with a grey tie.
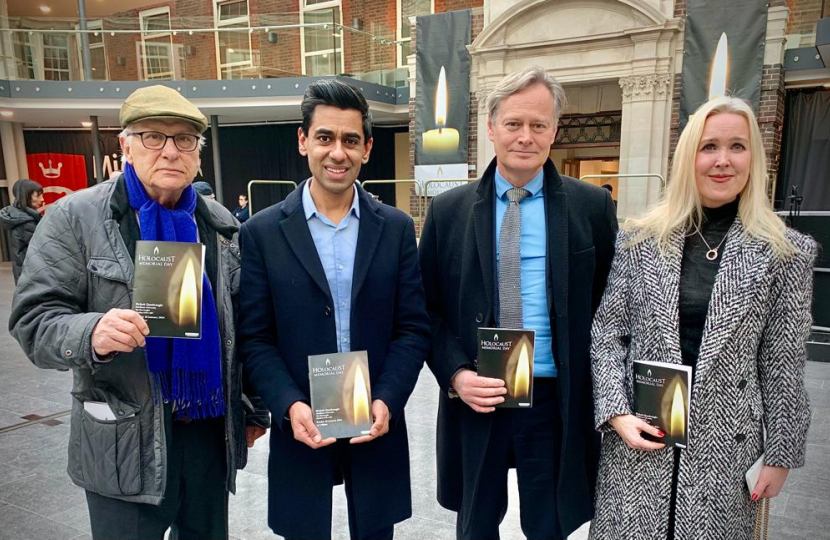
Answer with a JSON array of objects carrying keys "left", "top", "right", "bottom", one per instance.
[{"left": 495, "top": 169, "right": 556, "bottom": 377}]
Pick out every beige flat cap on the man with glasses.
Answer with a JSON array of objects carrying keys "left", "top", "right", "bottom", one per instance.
[{"left": 119, "top": 85, "right": 207, "bottom": 133}]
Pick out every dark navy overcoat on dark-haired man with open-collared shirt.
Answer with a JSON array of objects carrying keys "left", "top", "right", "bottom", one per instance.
[{"left": 234, "top": 183, "right": 429, "bottom": 538}]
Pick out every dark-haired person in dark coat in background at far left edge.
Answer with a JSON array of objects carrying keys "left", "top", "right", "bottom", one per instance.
[{"left": 0, "top": 179, "right": 43, "bottom": 284}]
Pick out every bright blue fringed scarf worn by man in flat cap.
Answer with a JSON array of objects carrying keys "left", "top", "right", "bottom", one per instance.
[{"left": 124, "top": 163, "right": 225, "bottom": 419}]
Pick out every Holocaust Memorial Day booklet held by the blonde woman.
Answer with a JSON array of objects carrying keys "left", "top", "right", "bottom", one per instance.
[{"left": 633, "top": 360, "right": 692, "bottom": 448}]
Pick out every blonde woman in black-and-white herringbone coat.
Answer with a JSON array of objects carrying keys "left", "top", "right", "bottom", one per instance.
[{"left": 591, "top": 97, "right": 816, "bottom": 540}]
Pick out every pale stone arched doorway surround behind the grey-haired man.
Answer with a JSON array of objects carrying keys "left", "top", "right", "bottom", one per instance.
[{"left": 470, "top": 0, "right": 682, "bottom": 216}]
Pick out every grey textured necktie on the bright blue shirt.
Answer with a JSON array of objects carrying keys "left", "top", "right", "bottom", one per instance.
[{"left": 499, "top": 188, "right": 530, "bottom": 328}]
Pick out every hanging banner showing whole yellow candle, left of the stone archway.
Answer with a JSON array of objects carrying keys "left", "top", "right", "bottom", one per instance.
[{"left": 415, "top": 10, "right": 472, "bottom": 196}]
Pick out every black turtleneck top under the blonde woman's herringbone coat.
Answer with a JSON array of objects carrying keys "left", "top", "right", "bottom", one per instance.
[{"left": 680, "top": 199, "right": 738, "bottom": 368}]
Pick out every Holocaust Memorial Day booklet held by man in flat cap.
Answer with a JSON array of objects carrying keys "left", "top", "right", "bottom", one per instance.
[{"left": 133, "top": 240, "right": 205, "bottom": 339}]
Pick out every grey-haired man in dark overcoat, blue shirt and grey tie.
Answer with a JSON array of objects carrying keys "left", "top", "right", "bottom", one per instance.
[{"left": 419, "top": 67, "right": 617, "bottom": 540}]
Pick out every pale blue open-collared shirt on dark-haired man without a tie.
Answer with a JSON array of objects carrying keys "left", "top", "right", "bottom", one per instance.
[{"left": 303, "top": 180, "right": 360, "bottom": 352}]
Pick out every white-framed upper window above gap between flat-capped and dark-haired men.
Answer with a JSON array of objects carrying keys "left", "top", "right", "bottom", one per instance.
[{"left": 213, "top": 0, "right": 251, "bottom": 79}]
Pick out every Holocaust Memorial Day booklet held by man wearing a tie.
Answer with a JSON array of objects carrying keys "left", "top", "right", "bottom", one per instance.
[{"left": 478, "top": 328, "right": 536, "bottom": 409}]
